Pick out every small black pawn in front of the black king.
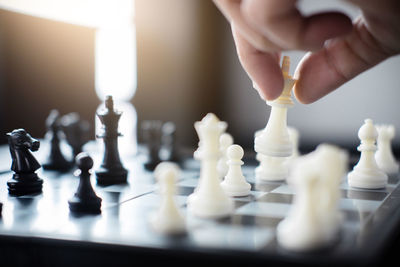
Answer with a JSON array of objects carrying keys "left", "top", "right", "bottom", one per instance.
[{"left": 68, "top": 152, "right": 102, "bottom": 214}]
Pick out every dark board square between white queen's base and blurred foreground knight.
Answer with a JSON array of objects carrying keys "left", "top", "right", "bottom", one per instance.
[{"left": 218, "top": 214, "right": 283, "bottom": 228}]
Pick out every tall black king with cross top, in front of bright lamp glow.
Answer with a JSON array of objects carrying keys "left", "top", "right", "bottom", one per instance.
[{"left": 96, "top": 96, "right": 128, "bottom": 185}]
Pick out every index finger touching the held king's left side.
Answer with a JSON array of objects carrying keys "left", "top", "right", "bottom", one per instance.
[{"left": 232, "top": 25, "right": 283, "bottom": 100}]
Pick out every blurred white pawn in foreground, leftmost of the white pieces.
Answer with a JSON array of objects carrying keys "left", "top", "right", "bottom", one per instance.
[{"left": 151, "top": 162, "right": 186, "bottom": 235}]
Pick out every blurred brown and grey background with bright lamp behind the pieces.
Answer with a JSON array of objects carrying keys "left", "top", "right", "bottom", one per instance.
[{"left": 0, "top": 0, "right": 400, "bottom": 154}]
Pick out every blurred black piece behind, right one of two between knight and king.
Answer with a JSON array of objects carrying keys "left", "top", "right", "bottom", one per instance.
[{"left": 60, "top": 112, "right": 90, "bottom": 159}]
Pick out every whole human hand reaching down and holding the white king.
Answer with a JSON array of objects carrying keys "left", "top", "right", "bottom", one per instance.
[{"left": 214, "top": 0, "right": 400, "bottom": 104}]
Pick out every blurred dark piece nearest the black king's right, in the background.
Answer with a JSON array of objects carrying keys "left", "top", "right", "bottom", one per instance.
[{"left": 141, "top": 120, "right": 163, "bottom": 171}]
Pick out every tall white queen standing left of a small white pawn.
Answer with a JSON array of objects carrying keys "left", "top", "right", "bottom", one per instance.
[{"left": 187, "top": 113, "right": 234, "bottom": 218}]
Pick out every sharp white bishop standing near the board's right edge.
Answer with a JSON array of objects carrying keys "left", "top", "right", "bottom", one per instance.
[{"left": 347, "top": 119, "right": 388, "bottom": 189}]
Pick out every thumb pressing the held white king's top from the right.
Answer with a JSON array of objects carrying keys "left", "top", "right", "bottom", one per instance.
[{"left": 294, "top": 17, "right": 390, "bottom": 104}]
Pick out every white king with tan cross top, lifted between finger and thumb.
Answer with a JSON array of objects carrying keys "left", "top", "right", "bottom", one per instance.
[{"left": 254, "top": 56, "right": 295, "bottom": 157}]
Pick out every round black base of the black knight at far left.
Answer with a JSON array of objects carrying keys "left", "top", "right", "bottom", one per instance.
[{"left": 7, "top": 173, "right": 43, "bottom": 196}]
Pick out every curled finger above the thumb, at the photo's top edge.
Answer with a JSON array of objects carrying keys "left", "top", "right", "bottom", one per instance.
[{"left": 241, "top": 0, "right": 352, "bottom": 50}]
